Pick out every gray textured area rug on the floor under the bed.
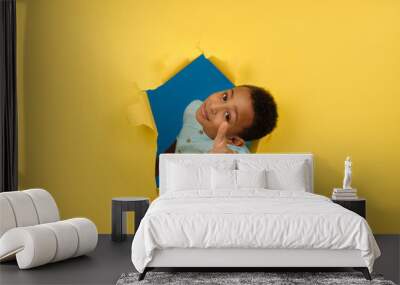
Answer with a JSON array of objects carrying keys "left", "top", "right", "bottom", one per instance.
[{"left": 117, "top": 272, "right": 395, "bottom": 285}]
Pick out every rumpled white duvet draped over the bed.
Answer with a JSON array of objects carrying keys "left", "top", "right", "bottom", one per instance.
[{"left": 132, "top": 189, "right": 380, "bottom": 272}]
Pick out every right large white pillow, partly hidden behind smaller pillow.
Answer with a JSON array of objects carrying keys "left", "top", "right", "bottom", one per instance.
[{"left": 238, "top": 159, "right": 309, "bottom": 191}]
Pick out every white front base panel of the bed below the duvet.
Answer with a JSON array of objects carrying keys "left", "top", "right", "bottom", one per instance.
[{"left": 147, "top": 248, "right": 367, "bottom": 267}]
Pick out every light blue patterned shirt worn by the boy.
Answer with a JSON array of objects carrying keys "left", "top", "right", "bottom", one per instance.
[{"left": 175, "top": 100, "right": 250, "bottom": 153}]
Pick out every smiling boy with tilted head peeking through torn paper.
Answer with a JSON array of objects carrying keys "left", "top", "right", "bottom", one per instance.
[{"left": 175, "top": 85, "right": 278, "bottom": 153}]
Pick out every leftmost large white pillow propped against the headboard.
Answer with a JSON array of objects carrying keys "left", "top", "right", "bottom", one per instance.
[{"left": 167, "top": 163, "right": 211, "bottom": 191}]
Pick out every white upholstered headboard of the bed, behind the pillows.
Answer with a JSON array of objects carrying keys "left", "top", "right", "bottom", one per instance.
[{"left": 159, "top": 153, "right": 314, "bottom": 195}]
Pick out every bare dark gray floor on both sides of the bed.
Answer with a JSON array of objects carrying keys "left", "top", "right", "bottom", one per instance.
[{"left": 0, "top": 235, "right": 400, "bottom": 285}]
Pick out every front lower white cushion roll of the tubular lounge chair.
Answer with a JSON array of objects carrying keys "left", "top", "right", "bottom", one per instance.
[{"left": 0, "top": 218, "right": 97, "bottom": 269}]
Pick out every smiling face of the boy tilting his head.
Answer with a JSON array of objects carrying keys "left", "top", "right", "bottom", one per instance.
[{"left": 196, "top": 87, "right": 254, "bottom": 145}]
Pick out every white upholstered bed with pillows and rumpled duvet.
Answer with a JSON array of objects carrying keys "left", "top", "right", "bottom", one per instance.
[{"left": 132, "top": 154, "right": 380, "bottom": 280}]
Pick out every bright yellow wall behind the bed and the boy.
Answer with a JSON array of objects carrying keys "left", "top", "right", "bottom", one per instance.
[{"left": 17, "top": 0, "right": 400, "bottom": 233}]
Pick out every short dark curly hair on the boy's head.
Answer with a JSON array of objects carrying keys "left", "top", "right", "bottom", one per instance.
[{"left": 238, "top": 85, "right": 278, "bottom": 141}]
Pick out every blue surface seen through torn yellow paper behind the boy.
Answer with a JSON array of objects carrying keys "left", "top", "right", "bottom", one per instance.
[{"left": 147, "top": 55, "right": 234, "bottom": 156}]
